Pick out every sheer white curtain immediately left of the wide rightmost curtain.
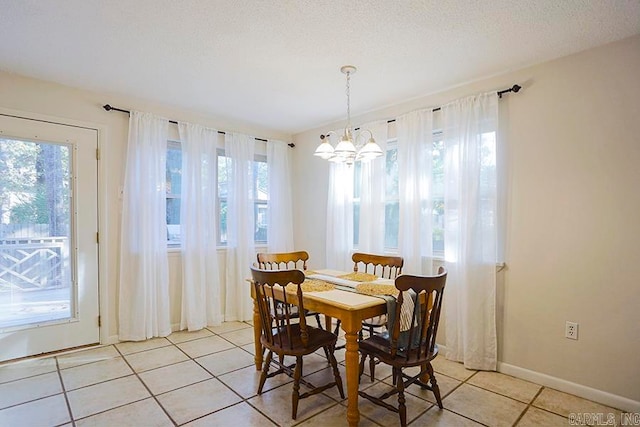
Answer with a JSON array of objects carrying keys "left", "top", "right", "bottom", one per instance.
[{"left": 396, "top": 109, "right": 433, "bottom": 274}]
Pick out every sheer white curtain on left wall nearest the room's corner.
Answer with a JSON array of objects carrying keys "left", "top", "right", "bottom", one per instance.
[{"left": 267, "top": 140, "right": 293, "bottom": 252}]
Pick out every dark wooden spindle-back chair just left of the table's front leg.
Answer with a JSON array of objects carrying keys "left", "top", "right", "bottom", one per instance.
[{"left": 251, "top": 267, "right": 344, "bottom": 420}]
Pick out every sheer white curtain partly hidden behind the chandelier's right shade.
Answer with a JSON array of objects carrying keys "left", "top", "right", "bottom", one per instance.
[{"left": 358, "top": 120, "right": 389, "bottom": 254}]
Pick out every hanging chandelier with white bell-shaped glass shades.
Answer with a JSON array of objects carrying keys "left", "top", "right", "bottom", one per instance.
[{"left": 313, "top": 65, "right": 383, "bottom": 165}]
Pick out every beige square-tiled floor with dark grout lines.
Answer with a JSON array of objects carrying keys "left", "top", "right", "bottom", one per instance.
[{"left": 0, "top": 322, "right": 620, "bottom": 427}]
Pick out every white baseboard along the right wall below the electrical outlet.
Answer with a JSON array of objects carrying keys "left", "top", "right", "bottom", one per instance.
[{"left": 498, "top": 362, "right": 640, "bottom": 412}]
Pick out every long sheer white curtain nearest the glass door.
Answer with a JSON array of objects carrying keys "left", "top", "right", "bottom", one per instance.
[{"left": 118, "top": 111, "right": 171, "bottom": 341}]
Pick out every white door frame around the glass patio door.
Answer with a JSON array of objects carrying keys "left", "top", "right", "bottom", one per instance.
[{"left": 0, "top": 106, "right": 112, "bottom": 345}]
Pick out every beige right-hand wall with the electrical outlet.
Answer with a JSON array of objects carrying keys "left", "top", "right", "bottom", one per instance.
[{"left": 294, "top": 36, "right": 640, "bottom": 410}]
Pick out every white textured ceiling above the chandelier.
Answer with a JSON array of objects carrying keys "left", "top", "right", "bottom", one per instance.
[{"left": 0, "top": 0, "right": 640, "bottom": 133}]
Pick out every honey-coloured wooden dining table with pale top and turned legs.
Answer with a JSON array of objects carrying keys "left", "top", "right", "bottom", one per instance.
[{"left": 251, "top": 269, "right": 393, "bottom": 426}]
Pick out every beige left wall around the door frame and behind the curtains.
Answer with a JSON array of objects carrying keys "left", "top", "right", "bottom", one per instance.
[{"left": 0, "top": 72, "right": 291, "bottom": 343}]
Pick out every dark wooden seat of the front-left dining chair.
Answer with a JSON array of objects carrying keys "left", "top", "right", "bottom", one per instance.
[{"left": 260, "top": 324, "right": 338, "bottom": 356}]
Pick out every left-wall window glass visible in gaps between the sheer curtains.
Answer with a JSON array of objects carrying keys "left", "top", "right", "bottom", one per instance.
[{"left": 166, "top": 141, "right": 269, "bottom": 246}]
